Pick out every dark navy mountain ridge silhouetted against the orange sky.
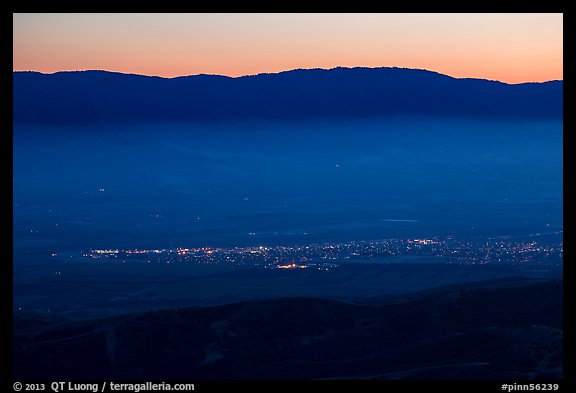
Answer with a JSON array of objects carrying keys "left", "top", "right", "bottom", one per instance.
[{"left": 13, "top": 68, "right": 563, "bottom": 125}]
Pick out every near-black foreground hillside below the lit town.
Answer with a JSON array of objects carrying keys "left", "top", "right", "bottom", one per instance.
[{"left": 14, "top": 280, "right": 563, "bottom": 381}]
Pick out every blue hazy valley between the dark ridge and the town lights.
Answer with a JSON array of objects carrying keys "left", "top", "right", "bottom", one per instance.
[{"left": 14, "top": 118, "right": 562, "bottom": 251}]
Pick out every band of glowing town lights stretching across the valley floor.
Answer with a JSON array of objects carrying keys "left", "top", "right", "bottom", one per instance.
[{"left": 50, "top": 236, "right": 563, "bottom": 270}]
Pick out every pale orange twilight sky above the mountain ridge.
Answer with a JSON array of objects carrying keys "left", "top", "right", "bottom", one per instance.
[{"left": 13, "top": 13, "right": 563, "bottom": 83}]
